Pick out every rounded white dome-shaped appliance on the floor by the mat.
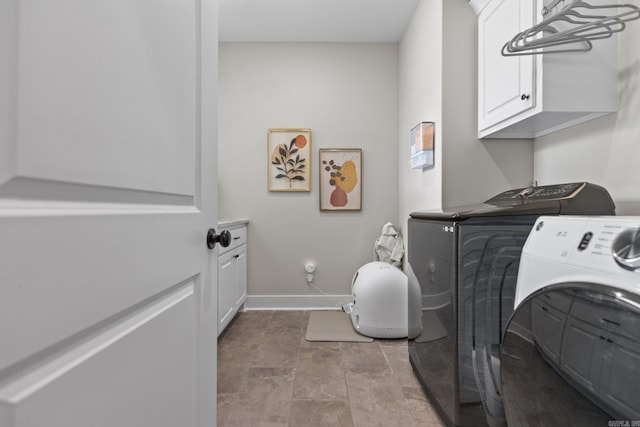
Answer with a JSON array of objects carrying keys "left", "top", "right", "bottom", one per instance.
[{"left": 343, "top": 261, "right": 422, "bottom": 338}]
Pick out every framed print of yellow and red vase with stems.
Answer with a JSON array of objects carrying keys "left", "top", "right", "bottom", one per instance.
[{"left": 318, "top": 148, "right": 362, "bottom": 211}]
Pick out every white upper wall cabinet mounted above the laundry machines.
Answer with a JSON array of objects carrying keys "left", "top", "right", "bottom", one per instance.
[{"left": 478, "top": 0, "right": 618, "bottom": 138}]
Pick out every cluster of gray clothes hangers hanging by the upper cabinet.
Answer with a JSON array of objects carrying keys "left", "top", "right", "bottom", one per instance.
[{"left": 502, "top": 0, "right": 640, "bottom": 56}]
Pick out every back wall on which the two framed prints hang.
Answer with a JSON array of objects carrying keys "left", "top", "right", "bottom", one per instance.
[{"left": 218, "top": 43, "right": 398, "bottom": 295}]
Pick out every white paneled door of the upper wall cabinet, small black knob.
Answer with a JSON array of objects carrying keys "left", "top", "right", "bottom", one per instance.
[{"left": 478, "top": 0, "right": 536, "bottom": 131}]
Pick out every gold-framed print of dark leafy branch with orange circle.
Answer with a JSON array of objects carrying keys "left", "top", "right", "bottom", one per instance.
[{"left": 267, "top": 128, "right": 311, "bottom": 192}]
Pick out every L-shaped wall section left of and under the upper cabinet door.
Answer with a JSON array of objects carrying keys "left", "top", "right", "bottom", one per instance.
[{"left": 442, "top": 0, "right": 533, "bottom": 207}]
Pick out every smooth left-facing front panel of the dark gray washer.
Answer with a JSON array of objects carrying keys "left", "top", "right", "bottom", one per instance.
[{"left": 408, "top": 218, "right": 486, "bottom": 427}]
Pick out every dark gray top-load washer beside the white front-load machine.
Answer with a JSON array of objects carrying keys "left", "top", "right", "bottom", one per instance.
[{"left": 407, "top": 182, "right": 615, "bottom": 427}]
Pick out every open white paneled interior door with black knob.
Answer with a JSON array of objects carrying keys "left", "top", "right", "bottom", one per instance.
[{"left": 0, "top": 0, "right": 217, "bottom": 427}]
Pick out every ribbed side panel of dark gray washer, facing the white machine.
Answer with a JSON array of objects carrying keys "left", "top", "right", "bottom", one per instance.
[{"left": 458, "top": 216, "right": 537, "bottom": 427}]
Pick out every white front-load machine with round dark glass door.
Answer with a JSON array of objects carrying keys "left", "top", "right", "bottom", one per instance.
[{"left": 501, "top": 216, "right": 640, "bottom": 427}]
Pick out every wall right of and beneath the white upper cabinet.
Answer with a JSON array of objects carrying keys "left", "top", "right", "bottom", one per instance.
[{"left": 534, "top": 21, "right": 640, "bottom": 215}]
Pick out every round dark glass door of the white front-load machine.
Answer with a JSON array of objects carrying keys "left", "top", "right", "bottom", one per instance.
[{"left": 500, "top": 283, "right": 640, "bottom": 427}]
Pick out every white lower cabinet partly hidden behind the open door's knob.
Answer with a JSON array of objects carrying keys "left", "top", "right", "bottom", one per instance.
[{"left": 218, "top": 224, "right": 247, "bottom": 335}]
